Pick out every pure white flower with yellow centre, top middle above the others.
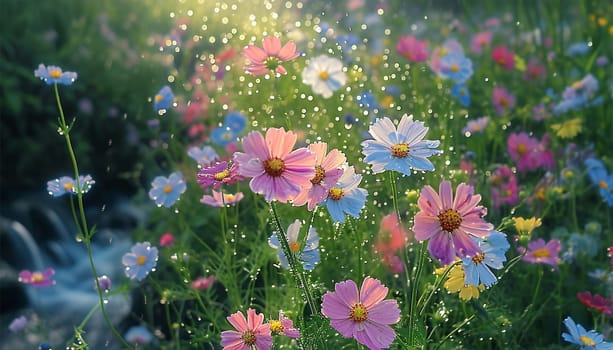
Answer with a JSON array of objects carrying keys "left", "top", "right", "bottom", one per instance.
[{"left": 302, "top": 55, "right": 347, "bottom": 98}]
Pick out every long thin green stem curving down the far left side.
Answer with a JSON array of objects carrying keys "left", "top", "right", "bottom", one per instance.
[{"left": 53, "top": 83, "right": 132, "bottom": 349}]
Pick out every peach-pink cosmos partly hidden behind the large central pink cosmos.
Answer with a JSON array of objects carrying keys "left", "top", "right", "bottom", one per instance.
[{"left": 292, "top": 142, "right": 347, "bottom": 211}]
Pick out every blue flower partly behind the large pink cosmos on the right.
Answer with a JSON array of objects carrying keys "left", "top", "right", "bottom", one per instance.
[{"left": 462, "top": 230, "right": 510, "bottom": 288}]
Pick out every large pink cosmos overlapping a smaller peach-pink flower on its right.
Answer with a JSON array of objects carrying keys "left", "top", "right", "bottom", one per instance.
[{"left": 234, "top": 128, "right": 315, "bottom": 203}]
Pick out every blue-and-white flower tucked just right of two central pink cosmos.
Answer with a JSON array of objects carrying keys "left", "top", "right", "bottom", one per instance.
[{"left": 324, "top": 166, "right": 368, "bottom": 223}]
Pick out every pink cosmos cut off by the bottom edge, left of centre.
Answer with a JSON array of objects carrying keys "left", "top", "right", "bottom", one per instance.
[{"left": 221, "top": 309, "right": 272, "bottom": 350}]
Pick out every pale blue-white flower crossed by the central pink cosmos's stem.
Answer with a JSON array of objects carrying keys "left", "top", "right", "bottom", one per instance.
[{"left": 268, "top": 220, "right": 319, "bottom": 271}]
